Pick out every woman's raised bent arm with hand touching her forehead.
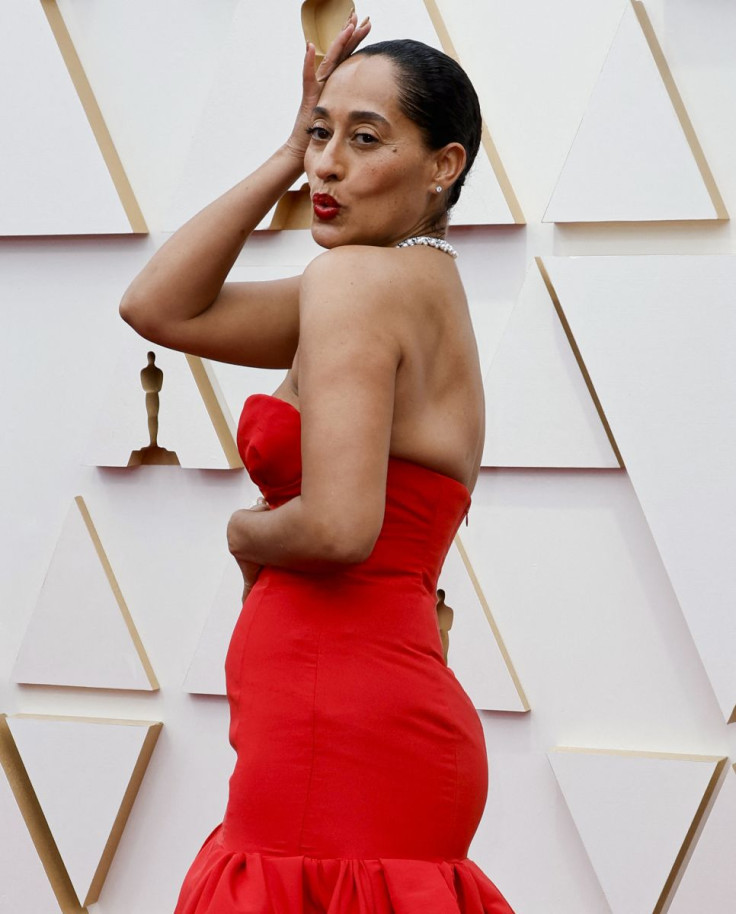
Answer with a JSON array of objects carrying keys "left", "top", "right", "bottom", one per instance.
[{"left": 120, "top": 13, "right": 370, "bottom": 368}]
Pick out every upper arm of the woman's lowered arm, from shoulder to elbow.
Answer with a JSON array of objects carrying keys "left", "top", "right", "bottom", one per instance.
[{"left": 298, "top": 248, "right": 401, "bottom": 555}]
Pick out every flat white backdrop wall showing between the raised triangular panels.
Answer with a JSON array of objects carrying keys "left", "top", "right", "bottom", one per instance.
[{"left": 0, "top": 0, "right": 736, "bottom": 914}]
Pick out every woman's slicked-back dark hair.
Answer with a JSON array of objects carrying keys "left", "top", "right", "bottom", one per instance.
[{"left": 353, "top": 38, "right": 481, "bottom": 209}]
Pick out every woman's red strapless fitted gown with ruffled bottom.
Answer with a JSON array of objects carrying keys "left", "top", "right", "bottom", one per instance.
[{"left": 175, "top": 394, "right": 513, "bottom": 914}]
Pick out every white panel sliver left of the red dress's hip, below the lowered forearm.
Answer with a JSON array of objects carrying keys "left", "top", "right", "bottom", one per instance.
[{"left": 184, "top": 559, "right": 243, "bottom": 695}]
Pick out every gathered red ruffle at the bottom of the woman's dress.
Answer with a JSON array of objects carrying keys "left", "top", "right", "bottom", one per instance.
[{"left": 174, "top": 825, "right": 514, "bottom": 914}]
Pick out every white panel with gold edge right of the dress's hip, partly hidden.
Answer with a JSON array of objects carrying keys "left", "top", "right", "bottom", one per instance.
[{"left": 438, "top": 537, "right": 529, "bottom": 711}]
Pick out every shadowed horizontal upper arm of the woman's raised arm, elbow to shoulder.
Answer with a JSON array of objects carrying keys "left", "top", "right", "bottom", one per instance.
[{"left": 120, "top": 276, "right": 301, "bottom": 368}]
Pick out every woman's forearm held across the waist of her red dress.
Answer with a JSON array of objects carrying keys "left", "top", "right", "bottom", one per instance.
[{"left": 227, "top": 496, "right": 377, "bottom": 571}]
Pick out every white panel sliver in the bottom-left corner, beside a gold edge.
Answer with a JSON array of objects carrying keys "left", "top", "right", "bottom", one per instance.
[{"left": 0, "top": 756, "right": 59, "bottom": 914}]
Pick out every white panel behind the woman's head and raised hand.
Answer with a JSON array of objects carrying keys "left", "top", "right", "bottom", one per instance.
[{"left": 167, "top": 0, "right": 523, "bottom": 229}]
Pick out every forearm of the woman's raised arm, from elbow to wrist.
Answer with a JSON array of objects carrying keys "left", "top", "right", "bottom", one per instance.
[{"left": 120, "top": 145, "right": 303, "bottom": 324}]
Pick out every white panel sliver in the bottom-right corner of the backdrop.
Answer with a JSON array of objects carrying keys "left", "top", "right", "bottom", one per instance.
[{"left": 668, "top": 767, "right": 736, "bottom": 914}]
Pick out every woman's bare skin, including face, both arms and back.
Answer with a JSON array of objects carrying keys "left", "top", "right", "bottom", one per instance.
[{"left": 121, "top": 14, "right": 484, "bottom": 595}]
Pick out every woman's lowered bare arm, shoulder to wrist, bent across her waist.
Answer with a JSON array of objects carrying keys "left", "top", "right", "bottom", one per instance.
[{"left": 228, "top": 247, "right": 401, "bottom": 569}]
